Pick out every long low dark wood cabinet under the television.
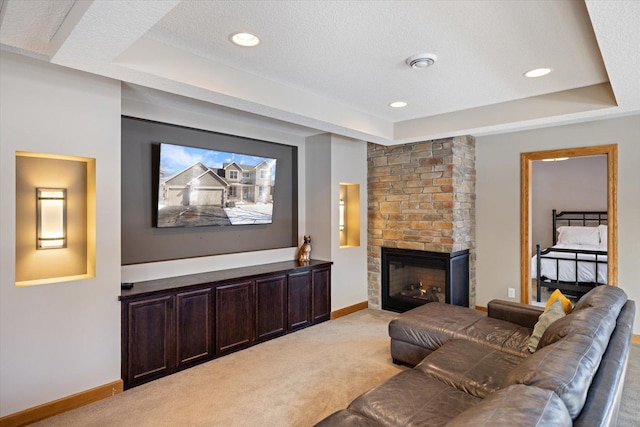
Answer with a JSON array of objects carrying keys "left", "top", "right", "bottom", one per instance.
[{"left": 120, "top": 260, "right": 331, "bottom": 389}]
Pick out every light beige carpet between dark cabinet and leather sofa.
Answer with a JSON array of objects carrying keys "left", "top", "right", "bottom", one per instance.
[{"left": 34, "top": 309, "right": 640, "bottom": 427}]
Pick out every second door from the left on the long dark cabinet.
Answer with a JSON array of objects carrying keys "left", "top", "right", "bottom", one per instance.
[{"left": 176, "top": 289, "right": 213, "bottom": 367}]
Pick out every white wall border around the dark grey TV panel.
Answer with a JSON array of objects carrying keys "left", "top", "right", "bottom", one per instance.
[{"left": 122, "top": 88, "right": 306, "bottom": 282}]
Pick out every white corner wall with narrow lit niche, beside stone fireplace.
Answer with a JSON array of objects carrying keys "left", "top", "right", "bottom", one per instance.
[{"left": 305, "top": 134, "right": 367, "bottom": 311}]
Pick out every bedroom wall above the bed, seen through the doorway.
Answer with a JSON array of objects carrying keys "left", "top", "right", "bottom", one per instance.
[{"left": 531, "top": 156, "right": 607, "bottom": 251}]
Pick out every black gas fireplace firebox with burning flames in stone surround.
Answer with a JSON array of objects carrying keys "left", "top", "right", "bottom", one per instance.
[{"left": 381, "top": 247, "right": 469, "bottom": 312}]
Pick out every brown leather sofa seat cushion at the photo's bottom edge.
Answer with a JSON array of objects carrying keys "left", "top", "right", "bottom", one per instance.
[{"left": 348, "top": 369, "right": 481, "bottom": 426}]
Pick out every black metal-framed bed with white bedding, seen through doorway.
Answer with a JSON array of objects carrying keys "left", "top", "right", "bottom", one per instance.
[{"left": 531, "top": 209, "right": 607, "bottom": 302}]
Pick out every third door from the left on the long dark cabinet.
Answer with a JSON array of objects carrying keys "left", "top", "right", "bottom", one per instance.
[{"left": 215, "top": 281, "right": 255, "bottom": 355}]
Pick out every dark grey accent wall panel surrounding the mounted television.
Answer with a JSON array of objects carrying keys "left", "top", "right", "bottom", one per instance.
[{"left": 122, "top": 117, "right": 298, "bottom": 265}]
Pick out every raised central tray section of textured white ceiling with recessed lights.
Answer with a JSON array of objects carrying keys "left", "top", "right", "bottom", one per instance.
[{"left": 147, "top": 1, "right": 608, "bottom": 121}]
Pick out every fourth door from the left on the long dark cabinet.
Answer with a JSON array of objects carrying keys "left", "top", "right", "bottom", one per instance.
[{"left": 256, "top": 274, "right": 287, "bottom": 341}]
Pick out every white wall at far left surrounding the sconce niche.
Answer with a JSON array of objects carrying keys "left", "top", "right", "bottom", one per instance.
[{"left": 0, "top": 52, "right": 120, "bottom": 416}]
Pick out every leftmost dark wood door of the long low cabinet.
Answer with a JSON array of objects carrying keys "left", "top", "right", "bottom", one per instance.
[{"left": 124, "top": 295, "right": 175, "bottom": 386}]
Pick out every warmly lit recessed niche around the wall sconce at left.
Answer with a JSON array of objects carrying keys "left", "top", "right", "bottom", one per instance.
[{"left": 15, "top": 151, "right": 96, "bottom": 286}]
